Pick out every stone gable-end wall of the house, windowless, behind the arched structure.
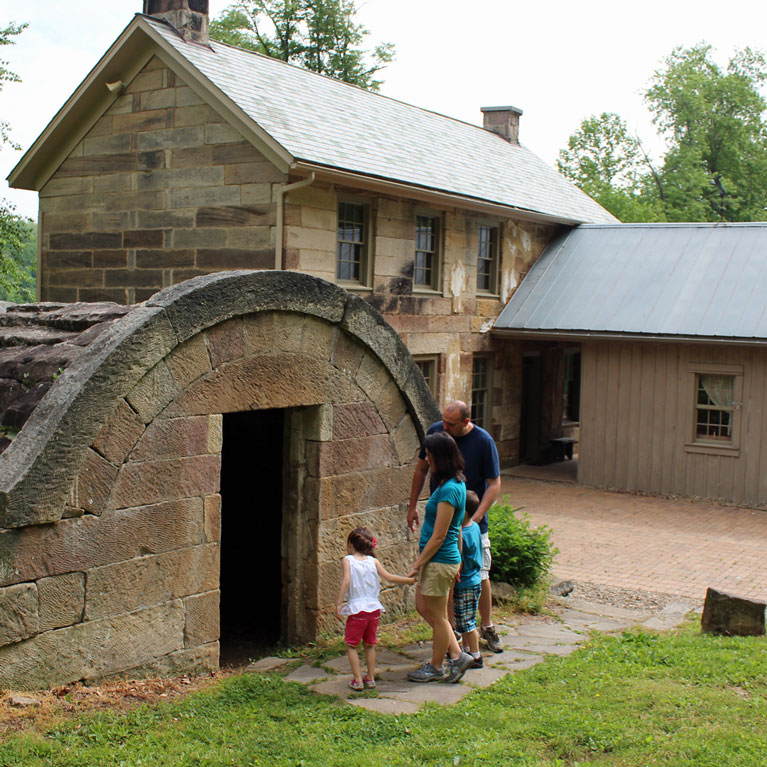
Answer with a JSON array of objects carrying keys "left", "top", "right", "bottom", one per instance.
[{"left": 40, "top": 58, "right": 285, "bottom": 304}]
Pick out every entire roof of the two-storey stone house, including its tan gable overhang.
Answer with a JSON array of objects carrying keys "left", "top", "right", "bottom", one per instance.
[{"left": 8, "top": 14, "right": 615, "bottom": 224}]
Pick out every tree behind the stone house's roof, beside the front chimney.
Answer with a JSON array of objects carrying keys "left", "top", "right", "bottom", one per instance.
[{"left": 210, "top": 0, "right": 394, "bottom": 91}]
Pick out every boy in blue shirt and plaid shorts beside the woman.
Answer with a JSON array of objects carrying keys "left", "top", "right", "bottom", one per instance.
[{"left": 453, "top": 490, "right": 483, "bottom": 668}]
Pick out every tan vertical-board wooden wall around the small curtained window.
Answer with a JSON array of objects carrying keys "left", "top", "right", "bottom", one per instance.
[{"left": 579, "top": 342, "right": 767, "bottom": 505}]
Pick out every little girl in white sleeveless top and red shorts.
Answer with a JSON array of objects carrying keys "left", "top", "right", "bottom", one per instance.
[{"left": 336, "top": 527, "right": 415, "bottom": 692}]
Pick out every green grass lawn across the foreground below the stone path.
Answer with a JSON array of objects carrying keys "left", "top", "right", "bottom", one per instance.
[{"left": 0, "top": 624, "right": 767, "bottom": 767}]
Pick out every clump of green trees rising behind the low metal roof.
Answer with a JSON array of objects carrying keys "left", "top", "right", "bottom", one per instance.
[{"left": 559, "top": 44, "right": 767, "bottom": 221}]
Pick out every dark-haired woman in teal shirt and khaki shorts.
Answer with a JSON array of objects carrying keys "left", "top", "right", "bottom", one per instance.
[{"left": 408, "top": 431, "right": 473, "bottom": 682}]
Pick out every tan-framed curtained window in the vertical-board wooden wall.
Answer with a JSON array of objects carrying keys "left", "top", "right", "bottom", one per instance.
[{"left": 686, "top": 363, "right": 743, "bottom": 455}]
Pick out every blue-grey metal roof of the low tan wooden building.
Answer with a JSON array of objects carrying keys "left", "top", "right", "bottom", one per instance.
[{"left": 494, "top": 223, "right": 767, "bottom": 340}]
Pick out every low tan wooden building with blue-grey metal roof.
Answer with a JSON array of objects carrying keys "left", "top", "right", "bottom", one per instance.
[{"left": 494, "top": 223, "right": 767, "bottom": 506}]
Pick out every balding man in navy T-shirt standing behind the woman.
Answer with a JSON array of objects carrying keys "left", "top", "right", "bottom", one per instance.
[{"left": 407, "top": 400, "right": 503, "bottom": 652}]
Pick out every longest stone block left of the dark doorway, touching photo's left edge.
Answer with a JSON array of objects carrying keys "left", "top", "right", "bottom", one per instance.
[{"left": 0, "top": 498, "right": 203, "bottom": 586}]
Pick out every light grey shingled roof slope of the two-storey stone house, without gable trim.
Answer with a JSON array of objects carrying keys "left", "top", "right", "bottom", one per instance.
[{"left": 139, "top": 17, "right": 615, "bottom": 223}]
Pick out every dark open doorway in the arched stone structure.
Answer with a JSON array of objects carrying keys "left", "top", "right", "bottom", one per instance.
[{"left": 220, "top": 410, "right": 285, "bottom": 666}]
